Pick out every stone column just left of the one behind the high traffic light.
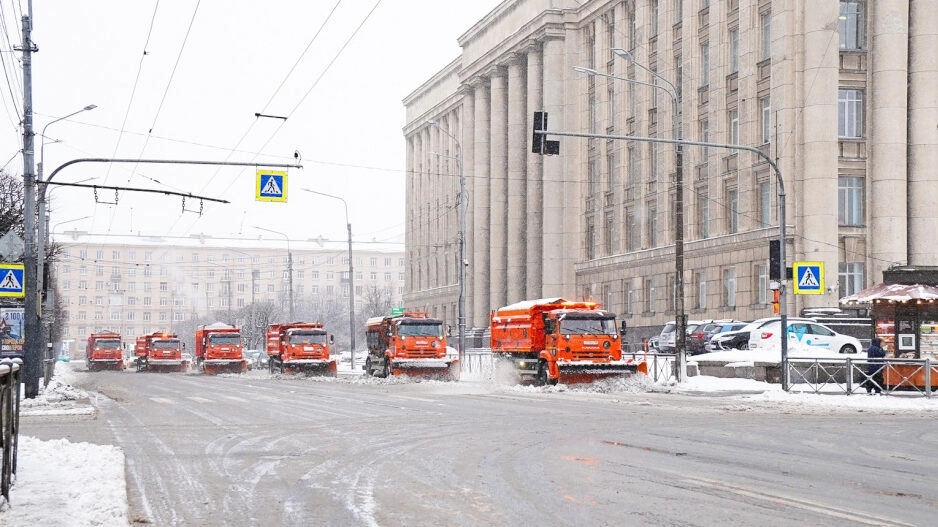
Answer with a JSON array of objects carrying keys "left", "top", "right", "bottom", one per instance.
[{"left": 506, "top": 54, "right": 530, "bottom": 304}]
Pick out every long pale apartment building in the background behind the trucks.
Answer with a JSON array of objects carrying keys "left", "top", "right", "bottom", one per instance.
[{"left": 53, "top": 231, "right": 405, "bottom": 353}]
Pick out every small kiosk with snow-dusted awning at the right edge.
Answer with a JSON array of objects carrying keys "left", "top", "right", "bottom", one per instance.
[{"left": 840, "top": 266, "right": 938, "bottom": 389}]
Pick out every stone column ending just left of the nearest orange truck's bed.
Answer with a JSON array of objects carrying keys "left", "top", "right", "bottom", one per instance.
[{"left": 469, "top": 79, "right": 492, "bottom": 327}]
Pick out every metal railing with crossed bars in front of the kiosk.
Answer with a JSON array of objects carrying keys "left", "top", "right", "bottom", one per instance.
[{"left": 787, "top": 357, "right": 938, "bottom": 397}]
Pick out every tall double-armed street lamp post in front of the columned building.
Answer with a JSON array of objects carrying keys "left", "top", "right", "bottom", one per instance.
[{"left": 612, "top": 48, "right": 687, "bottom": 382}]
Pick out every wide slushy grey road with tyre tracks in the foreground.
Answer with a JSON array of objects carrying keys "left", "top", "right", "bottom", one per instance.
[{"left": 16, "top": 372, "right": 938, "bottom": 526}]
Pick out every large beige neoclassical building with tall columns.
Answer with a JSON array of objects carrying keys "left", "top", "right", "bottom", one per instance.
[{"left": 404, "top": 0, "right": 938, "bottom": 327}]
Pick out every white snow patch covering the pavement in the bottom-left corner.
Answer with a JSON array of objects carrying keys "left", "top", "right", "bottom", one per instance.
[{"left": 0, "top": 436, "right": 129, "bottom": 527}]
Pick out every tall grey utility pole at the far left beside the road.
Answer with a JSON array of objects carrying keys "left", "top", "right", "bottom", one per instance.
[{"left": 22, "top": 4, "right": 43, "bottom": 399}]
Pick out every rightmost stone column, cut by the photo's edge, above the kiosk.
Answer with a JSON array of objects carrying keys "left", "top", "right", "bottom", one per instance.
[{"left": 908, "top": 2, "right": 938, "bottom": 265}]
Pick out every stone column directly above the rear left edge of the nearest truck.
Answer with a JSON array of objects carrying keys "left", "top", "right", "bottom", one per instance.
[{"left": 489, "top": 67, "right": 508, "bottom": 309}]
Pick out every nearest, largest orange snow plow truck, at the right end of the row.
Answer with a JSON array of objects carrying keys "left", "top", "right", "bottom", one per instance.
[{"left": 491, "top": 298, "right": 636, "bottom": 386}]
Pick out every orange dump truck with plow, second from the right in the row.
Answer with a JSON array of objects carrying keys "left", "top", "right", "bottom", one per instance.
[{"left": 363, "top": 312, "right": 459, "bottom": 380}]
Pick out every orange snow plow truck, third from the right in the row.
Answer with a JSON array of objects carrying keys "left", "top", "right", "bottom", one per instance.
[{"left": 267, "top": 322, "right": 338, "bottom": 377}]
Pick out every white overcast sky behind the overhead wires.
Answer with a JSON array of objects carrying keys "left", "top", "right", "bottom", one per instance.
[{"left": 0, "top": 0, "right": 499, "bottom": 246}]
